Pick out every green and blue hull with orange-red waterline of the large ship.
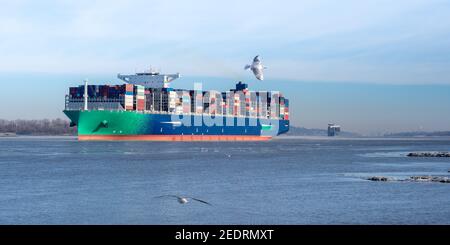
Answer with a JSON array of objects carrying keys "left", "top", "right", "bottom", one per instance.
[{"left": 64, "top": 110, "right": 289, "bottom": 141}]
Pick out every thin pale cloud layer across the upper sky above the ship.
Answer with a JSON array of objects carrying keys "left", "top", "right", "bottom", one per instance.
[{"left": 0, "top": 0, "right": 450, "bottom": 84}]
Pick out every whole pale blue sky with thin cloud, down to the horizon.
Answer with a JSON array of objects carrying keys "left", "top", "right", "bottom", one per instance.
[{"left": 0, "top": 0, "right": 450, "bottom": 134}]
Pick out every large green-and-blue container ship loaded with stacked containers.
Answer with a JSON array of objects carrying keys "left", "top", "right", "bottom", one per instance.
[{"left": 63, "top": 71, "right": 289, "bottom": 141}]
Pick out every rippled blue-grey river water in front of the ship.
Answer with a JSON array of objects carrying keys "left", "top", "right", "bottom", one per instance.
[{"left": 0, "top": 137, "right": 450, "bottom": 224}]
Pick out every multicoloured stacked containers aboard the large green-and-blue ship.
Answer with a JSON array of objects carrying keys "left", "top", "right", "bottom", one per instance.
[{"left": 68, "top": 83, "right": 289, "bottom": 120}]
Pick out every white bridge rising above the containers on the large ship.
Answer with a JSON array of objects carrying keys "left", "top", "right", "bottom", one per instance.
[{"left": 117, "top": 68, "right": 181, "bottom": 88}]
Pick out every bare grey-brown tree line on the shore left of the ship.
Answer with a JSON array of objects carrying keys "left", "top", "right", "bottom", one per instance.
[{"left": 0, "top": 119, "right": 76, "bottom": 135}]
